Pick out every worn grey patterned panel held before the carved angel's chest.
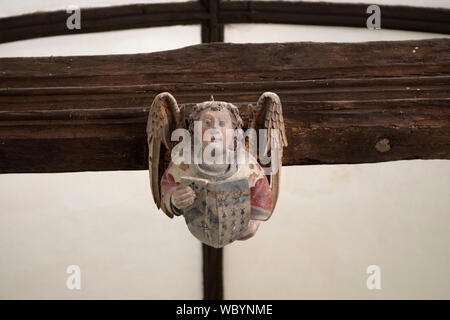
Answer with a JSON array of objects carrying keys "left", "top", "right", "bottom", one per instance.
[{"left": 181, "top": 177, "right": 251, "bottom": 248}]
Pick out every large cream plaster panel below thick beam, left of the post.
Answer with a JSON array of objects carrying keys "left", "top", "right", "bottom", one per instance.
[{"left": 0, "top": 171, "right": 202, "bottom": 299}]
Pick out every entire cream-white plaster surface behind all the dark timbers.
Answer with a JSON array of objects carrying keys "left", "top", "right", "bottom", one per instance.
[{"left": 0, "top": 0, "right": 450, "bottom": 299}]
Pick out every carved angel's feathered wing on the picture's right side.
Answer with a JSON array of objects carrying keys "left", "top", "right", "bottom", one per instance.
[{"left": 252, "top": 92, "right": 288, "bottom": 212}]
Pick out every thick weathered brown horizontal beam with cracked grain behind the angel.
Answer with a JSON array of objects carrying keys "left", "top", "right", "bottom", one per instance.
[{"left": 0, "top": 39, "right": 450, "bottom": 173}]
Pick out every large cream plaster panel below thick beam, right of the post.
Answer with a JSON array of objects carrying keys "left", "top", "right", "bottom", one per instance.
[{"left": 224, "top": 160, "right": 450, "bottom": 299}]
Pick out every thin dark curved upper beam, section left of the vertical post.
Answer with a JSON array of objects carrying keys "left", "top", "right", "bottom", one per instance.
[{"left": 0, "top": 1, "right": 209, "bottom": 43}]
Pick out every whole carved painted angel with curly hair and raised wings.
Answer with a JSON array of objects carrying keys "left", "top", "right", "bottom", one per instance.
[{"left": 147, "top": 92, "right": 287, "bottom": 248}]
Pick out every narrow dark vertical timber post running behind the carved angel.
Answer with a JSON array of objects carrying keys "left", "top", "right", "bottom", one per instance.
[{"left": 201, "top": 0, "right": 224, "bottom": 300}]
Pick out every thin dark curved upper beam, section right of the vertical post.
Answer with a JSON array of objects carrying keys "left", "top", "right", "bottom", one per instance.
[{"left": 219, "top": 1, "right": 450, "bottom": 34}]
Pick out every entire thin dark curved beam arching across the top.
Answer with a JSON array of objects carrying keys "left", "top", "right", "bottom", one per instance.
[{"left": 0, "top": 0, "right": 450, "bottom": 43}]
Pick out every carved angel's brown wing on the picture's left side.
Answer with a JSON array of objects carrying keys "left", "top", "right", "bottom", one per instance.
[{"left": 147, "top": 92, "right": 181, "bottom": 218}]
